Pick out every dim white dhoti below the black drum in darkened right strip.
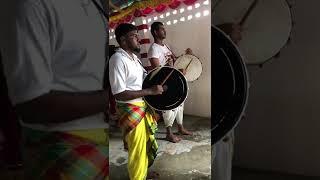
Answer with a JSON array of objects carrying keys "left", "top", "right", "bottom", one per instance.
[{"left": 212, "top": 130, "right": 234, "bottom": 180}]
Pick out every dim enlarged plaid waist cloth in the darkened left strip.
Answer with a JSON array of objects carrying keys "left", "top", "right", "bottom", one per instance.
[{"left": 23, "top": 128, "right": 109, "bottom": 180}]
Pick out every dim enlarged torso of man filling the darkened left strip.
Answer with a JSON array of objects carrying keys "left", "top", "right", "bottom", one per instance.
[{"left": 0, "top": 0, "right": 109, "bottom": 180}]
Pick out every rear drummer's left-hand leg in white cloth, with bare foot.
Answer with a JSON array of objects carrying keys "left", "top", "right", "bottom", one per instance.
[{"left": 162, "top": 110, "right": 181, "bottom": 143}]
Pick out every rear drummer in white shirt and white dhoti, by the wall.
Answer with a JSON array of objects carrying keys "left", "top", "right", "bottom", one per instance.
[{"left": 148, "top": 22, "right": 192, "bottom": 143}]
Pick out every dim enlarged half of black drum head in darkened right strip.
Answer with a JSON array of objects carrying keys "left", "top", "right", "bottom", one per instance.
[{"left": 211, "top": 26, "right": 249, "bottom": 144}]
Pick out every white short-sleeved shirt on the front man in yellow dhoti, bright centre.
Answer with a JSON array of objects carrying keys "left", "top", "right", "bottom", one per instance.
[{"left": 109, "top": 48, "right": 147, "bottom": 103}]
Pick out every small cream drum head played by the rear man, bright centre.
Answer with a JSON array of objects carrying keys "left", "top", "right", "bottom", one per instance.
[{"left": 174, "top": 54, "right": 202, "bottom": 82}]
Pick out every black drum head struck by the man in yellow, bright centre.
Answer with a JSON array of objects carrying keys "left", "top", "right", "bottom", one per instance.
[{"left": 142, "top": 66, "right": 188, "bottom": 111}]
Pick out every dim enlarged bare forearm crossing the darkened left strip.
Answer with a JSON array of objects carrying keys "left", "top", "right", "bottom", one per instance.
[{"left": 16, "top": 90, "right": 109, "bottom": 124}]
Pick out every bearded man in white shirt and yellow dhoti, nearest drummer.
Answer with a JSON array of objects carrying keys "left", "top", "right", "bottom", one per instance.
[{"left": 109, "top": 23, "right": 163, "bottom": 180}]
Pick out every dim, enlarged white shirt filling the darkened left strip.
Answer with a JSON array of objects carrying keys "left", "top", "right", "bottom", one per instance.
[{"left": 0, "top": 0, "right": 107, "bottom": 131}]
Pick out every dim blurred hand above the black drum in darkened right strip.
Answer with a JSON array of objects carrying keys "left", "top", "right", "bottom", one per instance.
[{"left": 217, "top": 23, "right": 242, "bottom": 44}]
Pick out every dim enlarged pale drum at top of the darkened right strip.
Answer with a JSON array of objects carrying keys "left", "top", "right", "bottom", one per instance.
[{"left": 212, "top": 0, "right": 292, "bottom": 64}]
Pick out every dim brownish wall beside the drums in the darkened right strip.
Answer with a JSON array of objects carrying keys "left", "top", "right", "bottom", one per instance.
[{"left": 235, "top": 0, "right": 320, "bottom": 176}]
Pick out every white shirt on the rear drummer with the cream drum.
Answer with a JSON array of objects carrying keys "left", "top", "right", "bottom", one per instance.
[{"left": 148, "top": 43, "right": 172, "bottom": 66}]
